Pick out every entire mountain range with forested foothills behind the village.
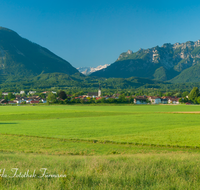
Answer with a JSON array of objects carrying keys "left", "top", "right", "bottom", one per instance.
[{"left": 0, "top": 27, "right": 200, "bottom": 89}]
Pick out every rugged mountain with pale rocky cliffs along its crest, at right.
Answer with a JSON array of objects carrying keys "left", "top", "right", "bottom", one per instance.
[{"left": 91, "top": 40, "right": 200, "bottom": 83}]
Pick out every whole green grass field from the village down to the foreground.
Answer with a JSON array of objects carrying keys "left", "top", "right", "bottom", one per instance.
[{"left": 0, "top": 105, "right": 200, "bottom": 189}]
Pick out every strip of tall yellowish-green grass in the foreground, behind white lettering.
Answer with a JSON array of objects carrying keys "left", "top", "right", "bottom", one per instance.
[{"left": 0, "top": 153, "right": 200, "bottom": 190}]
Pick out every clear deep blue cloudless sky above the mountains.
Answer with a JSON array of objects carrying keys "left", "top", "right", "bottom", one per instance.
[{"left": 0, "top": 0, "right": 200, "bottom": 68}]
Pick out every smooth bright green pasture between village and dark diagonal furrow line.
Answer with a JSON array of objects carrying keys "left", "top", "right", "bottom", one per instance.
[{"left": 0, "top": 105, "right": 200, "bottom": 149}]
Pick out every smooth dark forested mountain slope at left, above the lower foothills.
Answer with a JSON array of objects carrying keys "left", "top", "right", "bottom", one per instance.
[{"left": 0, "top": 27, "right": 78, "bottom": 76}]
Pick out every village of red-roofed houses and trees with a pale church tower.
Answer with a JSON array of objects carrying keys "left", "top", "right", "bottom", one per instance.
[{"left": 0, "top": 87, "right": 183, "bottom": 105}]
